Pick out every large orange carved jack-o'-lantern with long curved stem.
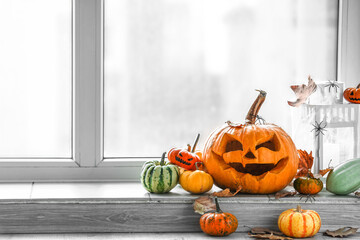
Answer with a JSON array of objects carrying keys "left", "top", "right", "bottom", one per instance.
[{"left": 203, "top": 90, "right": 299, "bottom": 194}]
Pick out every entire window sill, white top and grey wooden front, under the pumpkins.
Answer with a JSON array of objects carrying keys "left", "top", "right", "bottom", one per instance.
[{"left": 0, "top": 182, "right": 360, "bottom": 233}]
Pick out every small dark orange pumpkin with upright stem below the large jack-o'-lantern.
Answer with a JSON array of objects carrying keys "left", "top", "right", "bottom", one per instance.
[{"left": 200, "top": 197, "right": 238, "bottom": 236}]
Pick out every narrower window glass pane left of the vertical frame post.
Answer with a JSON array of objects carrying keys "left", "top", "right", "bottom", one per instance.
[{"left": 0, "top": 0, "right": 72, "bottom": 158}]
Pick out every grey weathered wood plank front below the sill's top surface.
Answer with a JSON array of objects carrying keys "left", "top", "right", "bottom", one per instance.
[{"left": 0, "top": 201, "right": 360, "bottom": 233}]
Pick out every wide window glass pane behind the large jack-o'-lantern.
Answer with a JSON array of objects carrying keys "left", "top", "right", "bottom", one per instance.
[{"left": 104, "top": 0, "right": 338, "bottom": 157}]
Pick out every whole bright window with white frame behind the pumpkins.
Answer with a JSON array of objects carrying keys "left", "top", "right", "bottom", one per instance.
[{"left": 0, "top": 0, "right": 360, "bottom": 181}]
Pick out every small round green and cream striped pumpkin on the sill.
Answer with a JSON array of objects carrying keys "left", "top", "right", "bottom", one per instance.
[{"left": 141, "top": 152, "right": 180, "bottom": 193}]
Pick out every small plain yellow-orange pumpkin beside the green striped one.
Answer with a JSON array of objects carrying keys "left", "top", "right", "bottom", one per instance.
[{"left": 179, "top": 162, "right": 214, "bottom": 194}]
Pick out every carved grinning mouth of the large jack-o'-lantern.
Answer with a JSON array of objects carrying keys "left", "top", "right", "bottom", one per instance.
[{"left": 229, "top": 158, "right": 288, "bottom": 176}]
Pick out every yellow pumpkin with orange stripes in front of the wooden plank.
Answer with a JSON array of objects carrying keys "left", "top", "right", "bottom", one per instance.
[{"left": 278, "top": 205, "right": 321, "bottom": 238}]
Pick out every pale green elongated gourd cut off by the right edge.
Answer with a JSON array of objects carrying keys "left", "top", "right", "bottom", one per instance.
[{"left": 326, "top": 158, "right": 360, "bottom": 195}]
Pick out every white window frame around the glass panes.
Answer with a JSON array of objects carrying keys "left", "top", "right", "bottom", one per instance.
[{"left": 0, "top": 0, "right": 360, "bottom": 182}]
